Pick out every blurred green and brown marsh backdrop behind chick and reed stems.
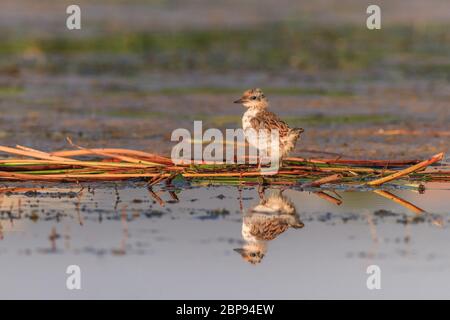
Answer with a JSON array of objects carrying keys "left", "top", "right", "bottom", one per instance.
[{"left": 0, "top": 0, "right": 450, "bottom": 158}]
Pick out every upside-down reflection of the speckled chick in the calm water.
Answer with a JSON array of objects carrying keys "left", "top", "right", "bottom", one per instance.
[{"left": 234, "top": 190, "right": 304, "bottom": 265}]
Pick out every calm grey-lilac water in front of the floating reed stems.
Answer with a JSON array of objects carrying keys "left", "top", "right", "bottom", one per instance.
[{"left": 0, "top": 184, "right": 450, "bottom": 299}]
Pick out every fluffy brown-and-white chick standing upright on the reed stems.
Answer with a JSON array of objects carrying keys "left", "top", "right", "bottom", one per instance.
[{"left": 234, "top": 88, "right": 304, "bottom": 159}]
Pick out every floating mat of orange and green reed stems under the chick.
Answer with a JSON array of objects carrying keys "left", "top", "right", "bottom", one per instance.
[{"left": 0, "top": 139, "right": 450, "bottom": 187}]
